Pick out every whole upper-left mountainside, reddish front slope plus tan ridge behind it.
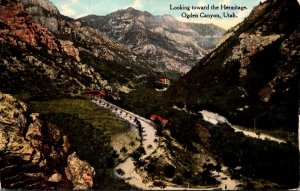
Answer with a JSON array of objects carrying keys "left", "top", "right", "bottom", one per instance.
[{"left": 0, "top": 0, "right": 153, "bottom": 98}]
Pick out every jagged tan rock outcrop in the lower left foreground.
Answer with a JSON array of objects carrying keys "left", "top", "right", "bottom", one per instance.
[{"left": 0, "top": 94, "right": 95, "bottom": 190}]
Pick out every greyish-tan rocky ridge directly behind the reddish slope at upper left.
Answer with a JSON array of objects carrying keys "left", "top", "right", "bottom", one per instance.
[{"left": 21, "top": 0, "right": 155, "bottom": 96}]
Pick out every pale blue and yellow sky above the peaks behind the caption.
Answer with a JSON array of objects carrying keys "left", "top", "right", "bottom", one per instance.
[{"left": 51, "top": 0, "right": 264, "bottom": 29}]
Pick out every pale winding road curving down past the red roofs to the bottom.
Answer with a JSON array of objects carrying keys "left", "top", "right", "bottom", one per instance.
[{"left": 92, "top": 98, "right": 239, "bottom": 190}]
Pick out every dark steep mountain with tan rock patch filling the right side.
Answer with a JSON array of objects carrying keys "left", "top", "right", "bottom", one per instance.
[{"left": 167, "top": 0, "right": 300, "bottom": 132}]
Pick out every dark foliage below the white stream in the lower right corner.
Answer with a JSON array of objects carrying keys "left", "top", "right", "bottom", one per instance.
[{"left": 209, "top": 125, "right": 299, "bottom": 188}]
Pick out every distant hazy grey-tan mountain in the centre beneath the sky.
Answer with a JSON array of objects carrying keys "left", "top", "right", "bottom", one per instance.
[{"left": 78, "top": 7, "right": 225, "bottom": 75}]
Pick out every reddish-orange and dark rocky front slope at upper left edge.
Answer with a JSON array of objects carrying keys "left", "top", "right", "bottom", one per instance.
[{"left": 0, "top": 0, "right": 108, "bottom": 97}]
